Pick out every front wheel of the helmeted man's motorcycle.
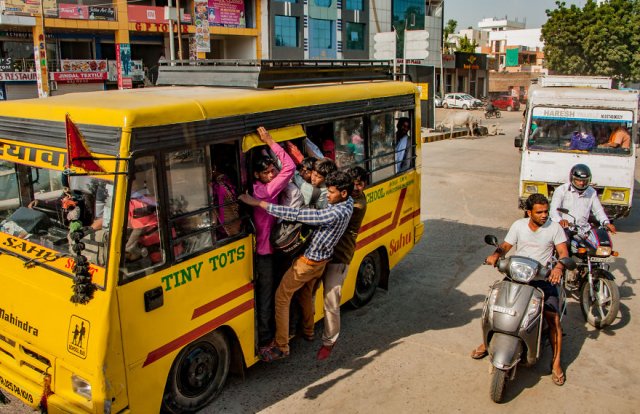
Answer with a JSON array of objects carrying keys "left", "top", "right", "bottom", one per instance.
[{"left": 580, "top": 274, "right": 620, "bottom": 329}]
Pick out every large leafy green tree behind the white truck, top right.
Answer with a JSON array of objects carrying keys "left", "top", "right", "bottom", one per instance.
[{"left": 542, "top": 0, "right": 640, "bottom": 81}]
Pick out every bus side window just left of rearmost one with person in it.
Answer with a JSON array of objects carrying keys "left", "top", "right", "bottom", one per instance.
[{"left": 369, "top": 112, "right": 396, "bottom": 183}]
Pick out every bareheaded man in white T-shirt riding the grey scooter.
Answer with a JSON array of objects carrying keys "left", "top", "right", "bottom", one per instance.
[{"left": 471, "top": 194, "right": 569, "bottom": 385}]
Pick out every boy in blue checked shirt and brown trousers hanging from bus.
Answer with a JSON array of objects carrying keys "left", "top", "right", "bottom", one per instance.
[{"left": 239, "top": 171, "right": 353, "bottom": 361}]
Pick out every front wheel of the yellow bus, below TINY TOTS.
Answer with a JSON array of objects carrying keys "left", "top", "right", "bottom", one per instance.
[{"left": 162, "top": 331, "right": 231, "bottom": 413}]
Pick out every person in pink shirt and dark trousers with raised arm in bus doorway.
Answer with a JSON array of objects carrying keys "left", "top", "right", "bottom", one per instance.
[{"left": 252, "top": 127, "right": 296, "bottom": 347}]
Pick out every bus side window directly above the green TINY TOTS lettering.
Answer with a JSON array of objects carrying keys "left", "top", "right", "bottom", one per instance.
[{"left": 165, "top": 148, "right": 213, "bottom": 259}]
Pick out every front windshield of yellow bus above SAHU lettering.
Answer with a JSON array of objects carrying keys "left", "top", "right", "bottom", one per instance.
[{"left": 0, "top": 161, "right": 113, "bottom": 265}]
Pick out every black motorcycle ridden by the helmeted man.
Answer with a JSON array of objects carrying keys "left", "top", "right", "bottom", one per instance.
[{"left": 558, "top": 208, "right": 620, "bottom": 329}]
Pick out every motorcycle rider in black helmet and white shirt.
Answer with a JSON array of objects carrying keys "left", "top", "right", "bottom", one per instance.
[{"left": 549, "top": 164, "right": 616, "bottom": 238}]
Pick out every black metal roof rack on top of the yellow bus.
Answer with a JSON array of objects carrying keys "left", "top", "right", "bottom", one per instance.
[{"left": 156, "top": 59, "right": 393, "bottom": 88}]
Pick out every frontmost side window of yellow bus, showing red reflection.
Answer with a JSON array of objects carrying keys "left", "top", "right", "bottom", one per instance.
[{"left": 124, "top": 156, "right": 165, "bottom": 273}]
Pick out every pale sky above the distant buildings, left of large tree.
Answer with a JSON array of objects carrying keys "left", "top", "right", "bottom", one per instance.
[{"left": 444, "top": 0, "right": 586, "bottom": 31}]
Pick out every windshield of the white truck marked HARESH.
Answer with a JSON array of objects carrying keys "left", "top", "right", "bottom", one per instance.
[{"left": 527, "top": 107, "right": 633, "bottom": 156}]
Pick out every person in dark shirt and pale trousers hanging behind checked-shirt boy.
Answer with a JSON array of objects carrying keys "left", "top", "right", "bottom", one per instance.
[{"left": 316, "top": 167, "right": 367, "bottom": 361}]
